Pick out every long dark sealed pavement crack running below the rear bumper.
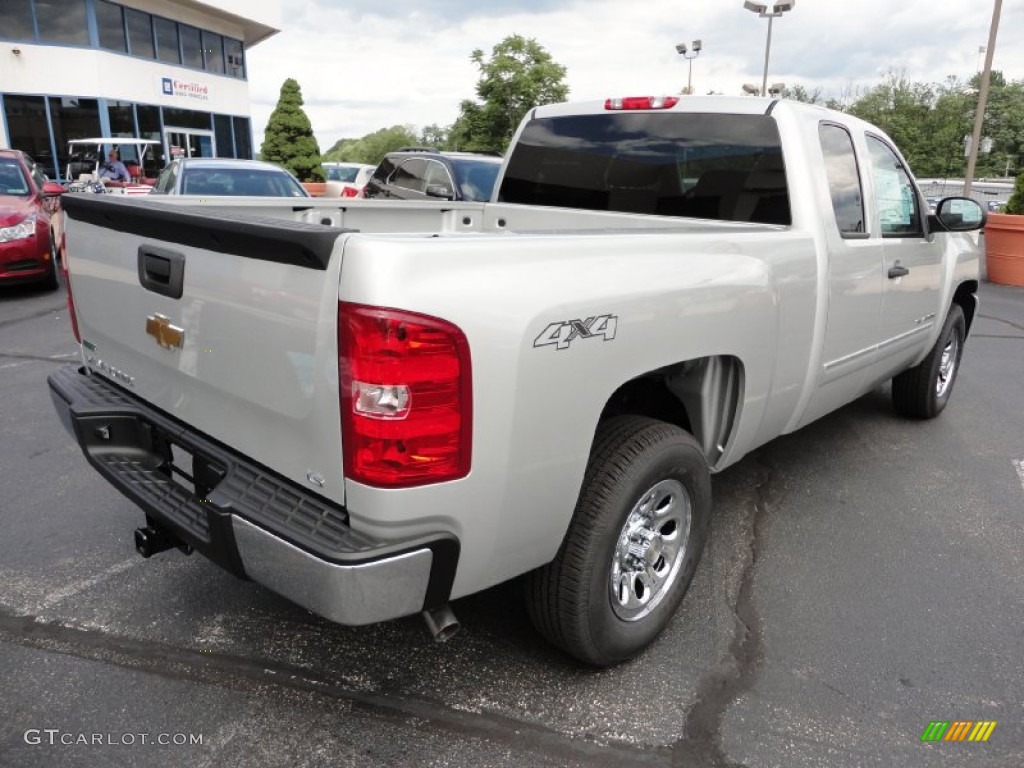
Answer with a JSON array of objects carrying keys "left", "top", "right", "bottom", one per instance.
[{"left": 0, "top": 606, "right": 668, "bottom": 768}]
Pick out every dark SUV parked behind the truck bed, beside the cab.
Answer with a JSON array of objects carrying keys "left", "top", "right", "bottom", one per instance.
[{"left": 362, "top": 147, "right": 502, "bottom": 203}]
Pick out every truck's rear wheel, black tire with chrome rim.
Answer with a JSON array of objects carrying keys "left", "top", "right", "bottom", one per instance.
[{"left": 525, "top": 416, "right": 711, "bottom": 667}]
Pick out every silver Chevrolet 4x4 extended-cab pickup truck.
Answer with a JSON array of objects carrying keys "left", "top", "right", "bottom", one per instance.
[{"left": 49, "top": 97, "right": 985, "bottom": 666}]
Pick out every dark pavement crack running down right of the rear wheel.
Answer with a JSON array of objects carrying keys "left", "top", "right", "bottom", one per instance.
[{"left": 672, "top": 453, "right": 775, "bottom": 768}]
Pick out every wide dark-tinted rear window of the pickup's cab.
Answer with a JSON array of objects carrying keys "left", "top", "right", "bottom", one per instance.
[{"left": 499, "top": 113, "right": 792, "bottom": 224}]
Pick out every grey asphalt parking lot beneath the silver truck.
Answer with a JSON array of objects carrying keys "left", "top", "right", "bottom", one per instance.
[{"left": 0, "top": 284, "right": 1024, "bottom": 768}]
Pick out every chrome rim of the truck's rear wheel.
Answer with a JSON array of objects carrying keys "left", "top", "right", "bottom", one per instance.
[{"left": 608, "top": 480, "right": 692, "bottom": 622}]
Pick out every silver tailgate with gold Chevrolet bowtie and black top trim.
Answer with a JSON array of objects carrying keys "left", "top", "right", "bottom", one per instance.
[{"left": 63, "top": 195, "right": 352, "bottom": 504}]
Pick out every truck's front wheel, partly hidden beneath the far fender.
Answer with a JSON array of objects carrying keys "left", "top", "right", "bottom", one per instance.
[{"left": 893, "top": 304, "right": 967, "bottom": 419}]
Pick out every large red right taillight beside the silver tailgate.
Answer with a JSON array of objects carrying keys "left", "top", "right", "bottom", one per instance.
[{"left": 338, "top": 302, "right": 473, "bottom": 487}]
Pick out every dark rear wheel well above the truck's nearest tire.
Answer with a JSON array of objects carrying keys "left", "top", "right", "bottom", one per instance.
[{"left": 601, "top": 355, "right": 742, "bottom": 467}]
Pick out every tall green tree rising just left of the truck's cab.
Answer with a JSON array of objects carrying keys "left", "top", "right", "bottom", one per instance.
[{"left": 449, "top": 35, "right": 569, "bottom": 152}]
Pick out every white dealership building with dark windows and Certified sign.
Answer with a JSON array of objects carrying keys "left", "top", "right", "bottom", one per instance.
[{"left": 0, "top": 0, "right": 281, "bottom": 179}]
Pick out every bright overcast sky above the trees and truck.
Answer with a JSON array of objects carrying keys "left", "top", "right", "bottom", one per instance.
[{"left": 241, "top": 0, "right": 1024, "bottom": 152}]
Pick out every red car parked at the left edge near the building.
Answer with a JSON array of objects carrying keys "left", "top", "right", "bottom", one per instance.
[{"left": 0, "top": 150, "right": 63, "bottom": 289}]
